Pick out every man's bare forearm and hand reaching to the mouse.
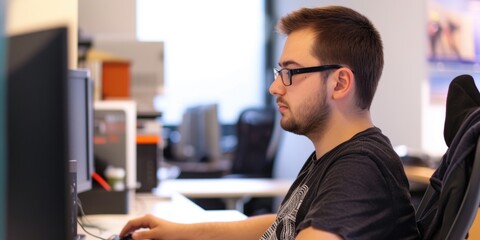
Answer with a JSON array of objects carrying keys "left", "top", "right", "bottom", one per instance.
[{"left": 120, "top": 214, "right": 275, "bottom": 240}]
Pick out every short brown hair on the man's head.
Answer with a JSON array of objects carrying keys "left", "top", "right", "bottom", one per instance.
[{"left": 277, "top": 6, "right": 383, "bottom": 109}]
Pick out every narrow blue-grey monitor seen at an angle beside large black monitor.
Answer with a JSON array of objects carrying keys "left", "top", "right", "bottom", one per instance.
[{"left": 68, "top": 69, "right": 93, "bottom": 193}]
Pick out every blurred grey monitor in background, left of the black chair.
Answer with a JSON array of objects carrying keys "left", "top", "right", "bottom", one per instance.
[{"left": 175, "top": 104, "right": 221, "bottom": 162}]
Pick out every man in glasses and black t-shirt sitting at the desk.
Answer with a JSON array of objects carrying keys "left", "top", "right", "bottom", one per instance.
[{"left": 121, "top": 6, "right": 418, "bottom": 240}]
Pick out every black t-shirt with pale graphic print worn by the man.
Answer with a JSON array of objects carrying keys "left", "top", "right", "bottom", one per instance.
[{"left": 261, "top": 127, "right": 419, "bottom": 240}]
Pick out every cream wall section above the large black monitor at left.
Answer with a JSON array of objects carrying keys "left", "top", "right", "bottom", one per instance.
[{"left": 6, "top": 0, "right": 78, "bottom": 68}]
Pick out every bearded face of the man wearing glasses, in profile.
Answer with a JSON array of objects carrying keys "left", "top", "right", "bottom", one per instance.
[{"left": 270, "top": 30, "right": 330, "bottom": 135}]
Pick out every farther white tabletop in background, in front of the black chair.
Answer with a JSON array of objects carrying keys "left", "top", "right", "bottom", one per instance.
[{"left": 153, "top": 178, "right": 293, "bottom": 212}]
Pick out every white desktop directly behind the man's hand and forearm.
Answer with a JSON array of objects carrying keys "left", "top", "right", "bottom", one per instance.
[{"left": 78, "top": 193, "right": 247, "bottom": 240}]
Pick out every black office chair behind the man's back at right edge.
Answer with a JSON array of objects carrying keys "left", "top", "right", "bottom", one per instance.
[{"left": 416, "top": 75, "right": 480, "bottom": 240}]
